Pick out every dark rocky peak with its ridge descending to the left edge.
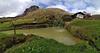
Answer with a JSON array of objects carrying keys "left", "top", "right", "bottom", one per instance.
[{"left": 0, "top": 5, "right": 39, "bottom": 23}]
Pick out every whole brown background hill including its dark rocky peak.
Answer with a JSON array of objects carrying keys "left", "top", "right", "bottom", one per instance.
[{"left": 0, "top": 6, "right": 71, "bottom": 23}]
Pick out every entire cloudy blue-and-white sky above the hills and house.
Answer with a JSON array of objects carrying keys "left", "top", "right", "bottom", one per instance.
[{"left": 0, "top": 0, "right": 100, "bottom": 17}]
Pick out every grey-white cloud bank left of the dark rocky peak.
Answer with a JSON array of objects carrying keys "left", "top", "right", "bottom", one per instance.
[{"left": 0, "top": 0, "right": 33, "bottom": 17}]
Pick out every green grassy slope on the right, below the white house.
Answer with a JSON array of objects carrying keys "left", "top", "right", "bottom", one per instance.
[{"left": 71, "top": 19, "right": 100, "bottom": 48}]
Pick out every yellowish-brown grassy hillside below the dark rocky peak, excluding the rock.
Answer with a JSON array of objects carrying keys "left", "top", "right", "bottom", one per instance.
[{"left": 0, "top": 9, "right": 69, "bottom": 31}]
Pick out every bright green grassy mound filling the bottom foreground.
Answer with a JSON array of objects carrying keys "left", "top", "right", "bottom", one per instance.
[{"left": 5, "top": 36, "right": 96, "bottom": 53}]
